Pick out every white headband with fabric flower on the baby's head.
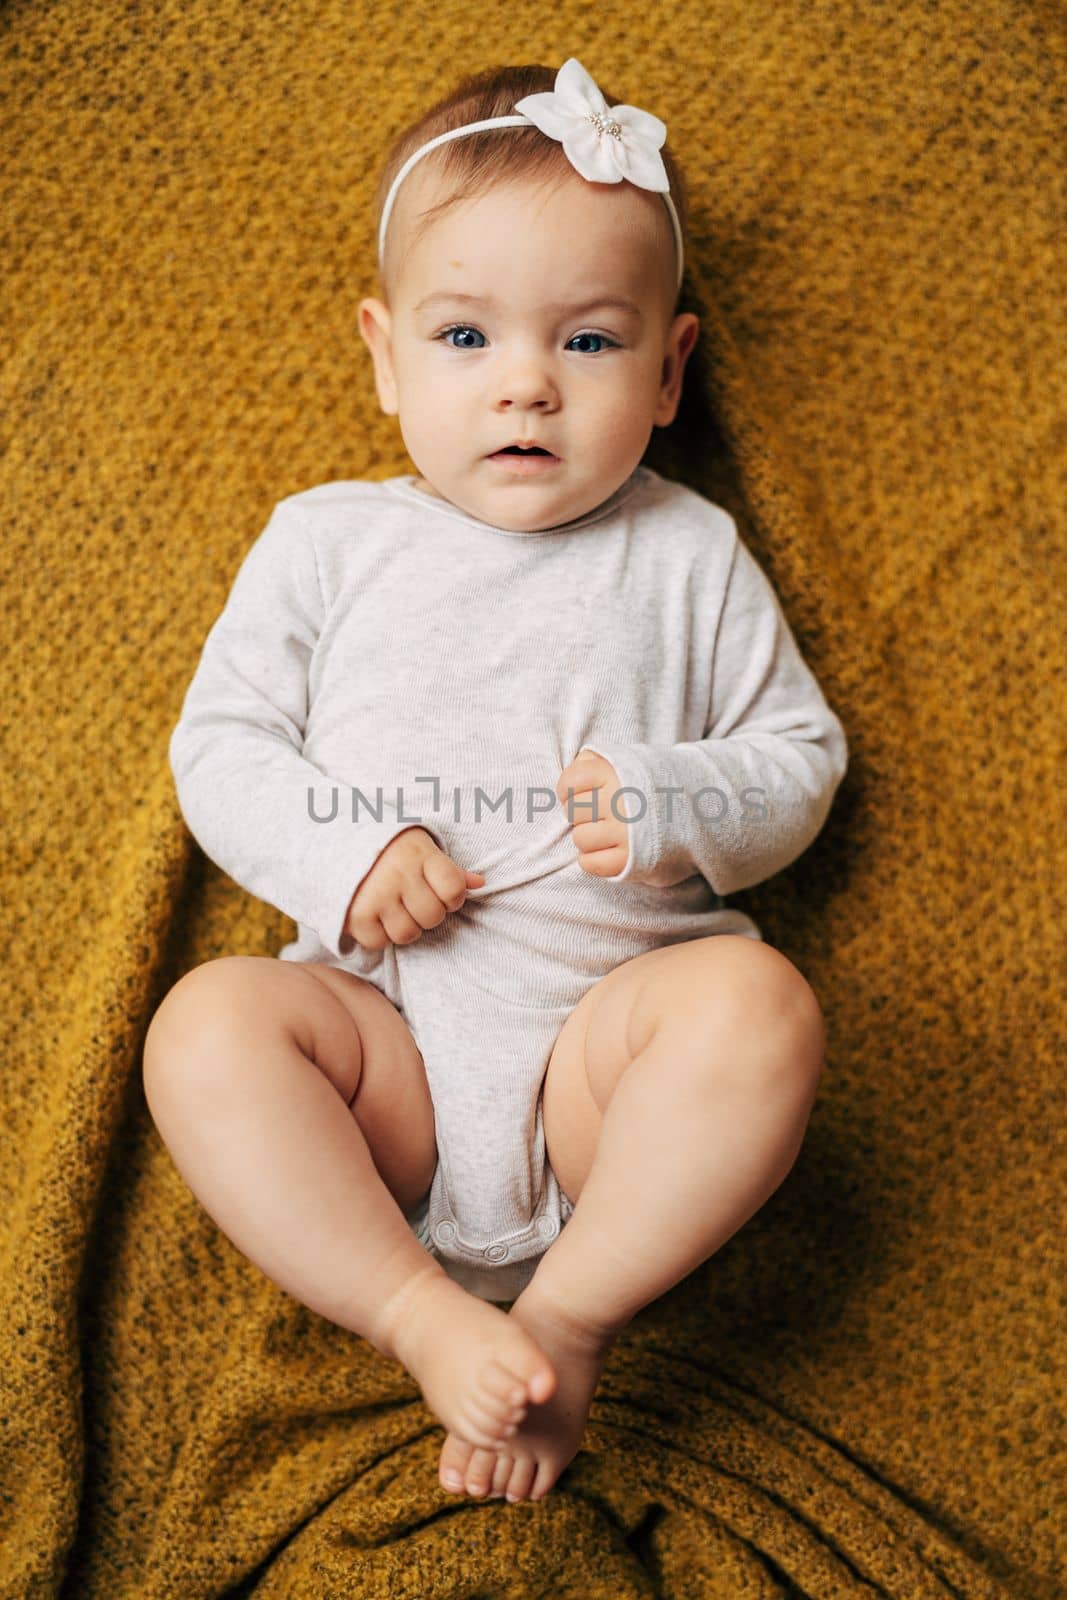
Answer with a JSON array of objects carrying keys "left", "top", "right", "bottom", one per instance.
[{"left": 378, "top": 56, "right": 683, "bottom": 288}]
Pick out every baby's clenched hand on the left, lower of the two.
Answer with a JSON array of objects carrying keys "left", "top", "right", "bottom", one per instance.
[{"left": 344, "top": 827, "right": 485, "bottom": 950}]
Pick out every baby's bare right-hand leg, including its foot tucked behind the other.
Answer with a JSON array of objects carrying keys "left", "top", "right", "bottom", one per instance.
[{"left": 440, "top": 934, "right": 825, "bottom": 1499}]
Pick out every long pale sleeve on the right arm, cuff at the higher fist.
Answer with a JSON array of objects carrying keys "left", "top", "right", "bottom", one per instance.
[{"left": 584, "top": 538, "right": 848, "bottom": 894}]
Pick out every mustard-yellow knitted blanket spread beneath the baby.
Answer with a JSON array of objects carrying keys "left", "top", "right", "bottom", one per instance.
[{"left": 0, "top": 0, "right": 1067, "bottom": 1600}]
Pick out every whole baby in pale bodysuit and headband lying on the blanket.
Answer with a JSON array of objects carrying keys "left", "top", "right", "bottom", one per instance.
[{"left": 144, "top": 59, "right": 846, "bottom": 1501}]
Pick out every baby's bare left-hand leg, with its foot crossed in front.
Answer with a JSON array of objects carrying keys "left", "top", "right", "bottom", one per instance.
[{"left": 144, "top": 955, "right": 555, "bottom": 1445}]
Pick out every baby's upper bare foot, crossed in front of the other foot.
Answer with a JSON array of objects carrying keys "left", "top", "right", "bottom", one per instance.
[{"left": 382, "top": 1266, "right": 555, "bottom": 1446}]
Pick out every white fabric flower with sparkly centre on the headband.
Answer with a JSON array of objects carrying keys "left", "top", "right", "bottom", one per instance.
[{"left": 515, "top": 56, "right": 670, "bottom": 194}]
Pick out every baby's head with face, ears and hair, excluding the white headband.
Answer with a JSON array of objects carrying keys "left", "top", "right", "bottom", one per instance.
[{"left": 360, "top": 66, "right": 699, "bottom": 531}]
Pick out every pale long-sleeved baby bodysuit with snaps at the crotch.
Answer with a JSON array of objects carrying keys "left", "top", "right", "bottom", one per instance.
[{"left": 170, "top": 466, "right": 848, "bottom": 1301}]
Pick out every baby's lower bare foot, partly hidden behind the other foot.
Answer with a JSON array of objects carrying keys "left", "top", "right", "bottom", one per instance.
[{"left": 438, "top": 1283, "right": 616, "bottom": 1501}]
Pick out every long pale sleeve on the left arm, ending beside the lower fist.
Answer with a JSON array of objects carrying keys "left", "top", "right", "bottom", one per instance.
[{"left": 170, "top": 501, "right": 440, "bottom": 957}]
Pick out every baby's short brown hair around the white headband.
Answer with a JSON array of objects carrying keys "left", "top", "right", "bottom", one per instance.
[{"left": 374, "top": 66, "right": 689, "bottom": 313}]
